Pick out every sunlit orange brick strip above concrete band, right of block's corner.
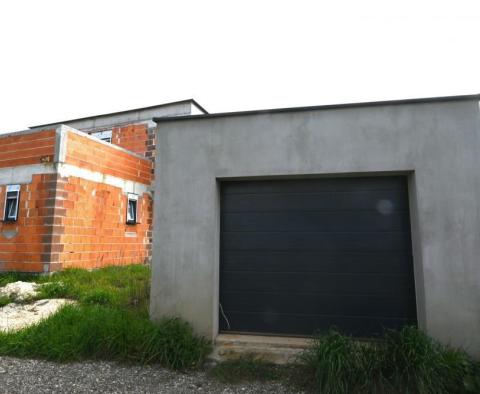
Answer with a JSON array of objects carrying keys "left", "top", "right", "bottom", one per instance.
[{"left": 65, "top": 132, "right": 152, "bottom": 184}]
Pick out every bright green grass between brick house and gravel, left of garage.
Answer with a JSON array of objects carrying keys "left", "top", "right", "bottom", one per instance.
[{"left": 0, "top": 265, "right": 210, "bottom": 369}]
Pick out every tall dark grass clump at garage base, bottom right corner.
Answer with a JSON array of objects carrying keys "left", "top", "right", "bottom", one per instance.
[{"left": 299, "top": 327, "right": 480, "bottom": 394}]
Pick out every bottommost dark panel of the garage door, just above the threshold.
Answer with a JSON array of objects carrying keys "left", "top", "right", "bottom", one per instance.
[{"left": 220, "top": 312, "right": 415, "bottom": 338}]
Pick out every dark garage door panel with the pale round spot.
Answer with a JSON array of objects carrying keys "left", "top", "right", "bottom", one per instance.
[{"left": 222, "top": 190, "right": 406, "bottom": 213}]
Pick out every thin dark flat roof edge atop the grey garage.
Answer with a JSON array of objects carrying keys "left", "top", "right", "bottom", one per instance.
[{"left": 153, "top": 94, "right": 480, "bottom": 123}]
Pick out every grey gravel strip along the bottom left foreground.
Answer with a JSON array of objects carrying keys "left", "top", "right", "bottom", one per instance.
[{"left": 0, "top": 357, "right": 302, "bottom": 394}]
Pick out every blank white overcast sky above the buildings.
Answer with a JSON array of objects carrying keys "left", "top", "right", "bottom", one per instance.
[{"left": 0, "top": 0, "right": 480, "bottom": 133}]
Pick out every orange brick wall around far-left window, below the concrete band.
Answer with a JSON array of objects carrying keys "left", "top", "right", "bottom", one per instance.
[{"left": 0, "top": 175, "right": 59, "bottom": 272}]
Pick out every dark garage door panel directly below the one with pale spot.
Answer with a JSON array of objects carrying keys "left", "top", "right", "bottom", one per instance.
[{"left": 221, "top": 211, "right": 410, "bottom": 232}]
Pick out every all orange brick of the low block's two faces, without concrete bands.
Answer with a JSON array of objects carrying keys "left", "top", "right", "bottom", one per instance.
[{"left": 0, "top": 130, "right": 152, "bottom": 272}]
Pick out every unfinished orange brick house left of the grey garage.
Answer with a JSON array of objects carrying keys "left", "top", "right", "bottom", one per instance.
[{"left": 0, "top": 100, "right": 206, "bottom": 272}]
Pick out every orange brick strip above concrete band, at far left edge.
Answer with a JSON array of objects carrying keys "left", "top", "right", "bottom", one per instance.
[{"left": 0, "top": 130, "right": 55, "bottom": 168}]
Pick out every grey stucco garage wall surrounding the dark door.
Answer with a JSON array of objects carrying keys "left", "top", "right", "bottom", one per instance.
[{"left": 151, "top": 100, "right": 480, "bottom": 354}]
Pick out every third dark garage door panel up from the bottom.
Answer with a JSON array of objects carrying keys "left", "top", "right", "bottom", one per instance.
[{"left": 220, "top": 271, "right": 412, "bottom": 295}]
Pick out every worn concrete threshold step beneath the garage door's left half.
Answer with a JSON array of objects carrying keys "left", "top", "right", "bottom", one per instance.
[{"left": 210, "top": 334, "right": 311, "bottom": 364}]
